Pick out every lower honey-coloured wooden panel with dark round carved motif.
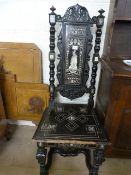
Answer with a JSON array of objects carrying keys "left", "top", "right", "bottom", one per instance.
[{"left": 0, "top": 73, "right": 49, "bottom": 121}]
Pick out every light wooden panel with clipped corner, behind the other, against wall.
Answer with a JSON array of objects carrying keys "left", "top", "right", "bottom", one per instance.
[{"left": 0, "top": 42, "right": 42, "bottom": 83}]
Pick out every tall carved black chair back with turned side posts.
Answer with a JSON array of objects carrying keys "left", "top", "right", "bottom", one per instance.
[{"left": 49, "top": 4, "right": 104, "bottom": 107}]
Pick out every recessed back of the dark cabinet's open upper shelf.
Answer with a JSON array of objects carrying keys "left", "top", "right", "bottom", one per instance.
[{"left": 110, "top": 20, "right": 131, "bottom": 59}]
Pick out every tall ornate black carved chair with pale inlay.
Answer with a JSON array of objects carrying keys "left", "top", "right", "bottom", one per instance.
[{"left": 33, "top": 4, "right": 109, "bottom": 175}]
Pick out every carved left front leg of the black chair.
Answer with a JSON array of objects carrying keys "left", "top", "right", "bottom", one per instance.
[{"left": 36, "top": 142, "right": 48, "bottom": 175}]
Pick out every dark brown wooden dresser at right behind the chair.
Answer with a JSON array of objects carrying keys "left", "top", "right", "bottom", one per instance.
[{"left": 96, "top": 0, "right": 131, "bottom": 158}]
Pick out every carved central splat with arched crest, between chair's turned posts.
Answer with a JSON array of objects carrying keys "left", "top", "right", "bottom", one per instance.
[{"left": 57, "top": 4, "right": 93, "bottom": 100}]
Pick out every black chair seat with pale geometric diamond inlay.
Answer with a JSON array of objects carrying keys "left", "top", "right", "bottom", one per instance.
[{"left": 33, "top": 104, "right": 107, "bottom": 143}]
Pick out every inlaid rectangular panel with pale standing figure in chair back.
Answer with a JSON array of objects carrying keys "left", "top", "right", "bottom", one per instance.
[{"left": 64, "top": 25, "right": 86, "bottom": 85}]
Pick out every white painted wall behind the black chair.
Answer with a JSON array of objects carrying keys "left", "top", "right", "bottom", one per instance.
[{"left": 0, "top": 0, "right": 114, "bottom": 104}]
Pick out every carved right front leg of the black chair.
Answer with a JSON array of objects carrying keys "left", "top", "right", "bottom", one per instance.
[{"left": 86, "top": 145, "right": 105, "bottom": 175}]
